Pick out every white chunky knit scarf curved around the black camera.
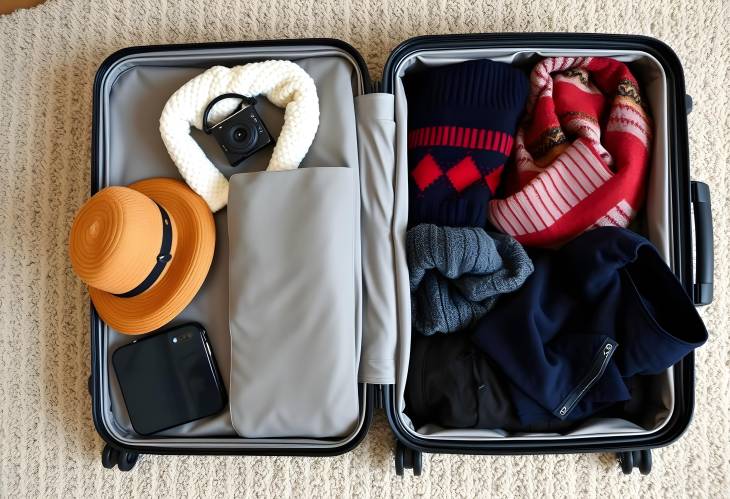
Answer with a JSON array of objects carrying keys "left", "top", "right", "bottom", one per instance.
[{"left": 160, "top": 61, "right": 319, "bottom": 212}]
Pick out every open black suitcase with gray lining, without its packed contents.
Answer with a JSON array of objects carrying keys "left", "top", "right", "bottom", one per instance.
[{"left": 89, "top": 33, "right": 713, "bottom": 475}]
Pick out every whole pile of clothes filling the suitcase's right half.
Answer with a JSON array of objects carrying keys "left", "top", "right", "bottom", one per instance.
[{"left": 404, "top": 57, "right": 692, "bottom": 431}]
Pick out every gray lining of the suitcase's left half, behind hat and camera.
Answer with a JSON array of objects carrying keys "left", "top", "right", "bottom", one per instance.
[{"left": 97, "top": 45, "right": 365, "bottom": 449}]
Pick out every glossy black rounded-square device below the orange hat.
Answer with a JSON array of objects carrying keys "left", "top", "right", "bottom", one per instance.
[{"left": 112, "top": 323, "right": 226, "bottom": 435}]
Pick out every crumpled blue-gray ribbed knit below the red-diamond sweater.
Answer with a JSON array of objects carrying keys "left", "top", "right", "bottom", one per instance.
[{"left": 406, "top": 224, "right": 534, "bottom": 335}]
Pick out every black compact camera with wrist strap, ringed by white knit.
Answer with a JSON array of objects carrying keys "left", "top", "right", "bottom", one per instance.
[{"left": 203, "top": 94, "right": 274, "bottom": 166}]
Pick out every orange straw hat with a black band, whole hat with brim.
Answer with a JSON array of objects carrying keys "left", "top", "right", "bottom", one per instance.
[{"left": 69, "top": 178, "right": 215, "bottom": 334}]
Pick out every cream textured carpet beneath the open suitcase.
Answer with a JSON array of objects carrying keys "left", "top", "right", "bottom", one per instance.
[{"left": 0, "top": 0, "right": 730, "bottom": 497}]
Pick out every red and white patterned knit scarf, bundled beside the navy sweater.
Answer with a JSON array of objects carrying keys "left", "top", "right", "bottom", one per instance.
[{"left": 489, "top": 57, "right": 652, "bottom": 246}]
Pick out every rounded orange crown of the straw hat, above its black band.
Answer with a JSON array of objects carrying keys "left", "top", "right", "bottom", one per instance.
[{"left": 69, "top": 187, "right": 163, "bottom": 294}]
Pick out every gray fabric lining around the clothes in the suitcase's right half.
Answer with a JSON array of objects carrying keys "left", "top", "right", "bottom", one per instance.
[{"left": 393, "top": 47, "right": 675, "bottom": 441}]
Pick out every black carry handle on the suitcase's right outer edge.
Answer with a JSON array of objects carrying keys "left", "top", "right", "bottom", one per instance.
[{"left": 691, "top": 181, "right": 715, "bottom": 305}]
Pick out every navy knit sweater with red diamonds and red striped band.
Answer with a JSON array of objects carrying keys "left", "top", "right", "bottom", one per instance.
[{"left": 404, "top": 59, "right": 529, "bottom": 227}]
